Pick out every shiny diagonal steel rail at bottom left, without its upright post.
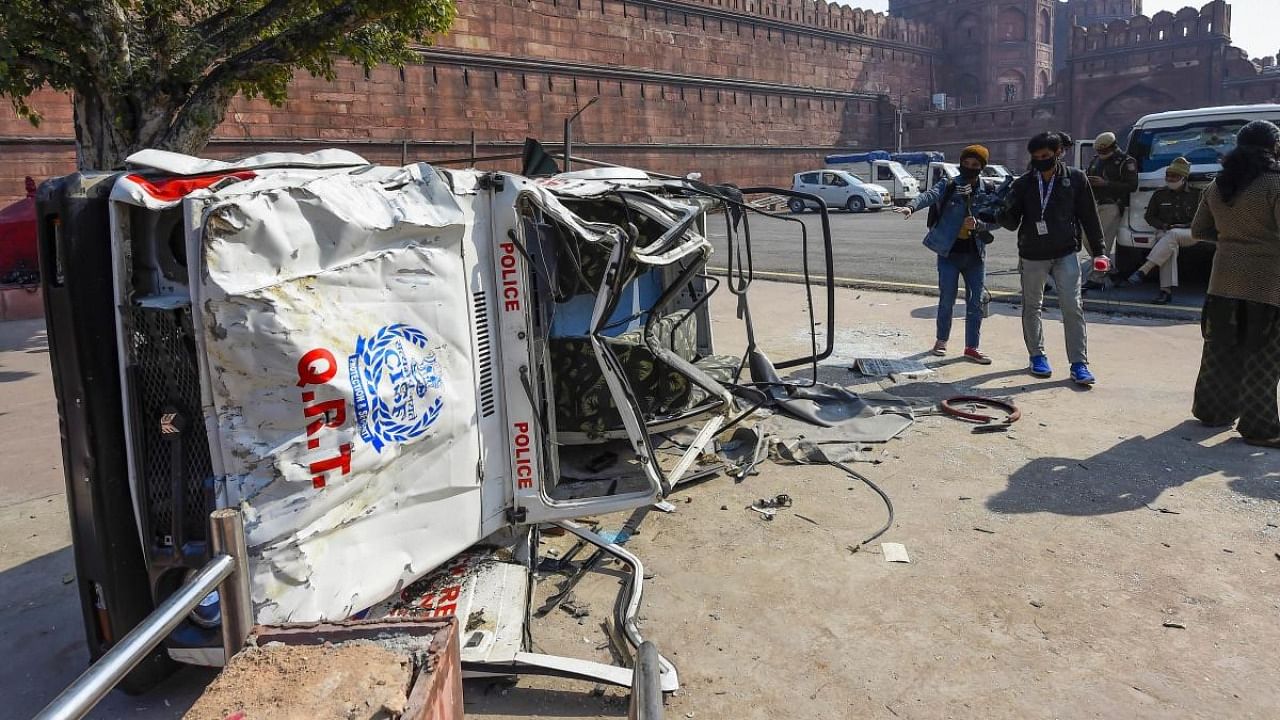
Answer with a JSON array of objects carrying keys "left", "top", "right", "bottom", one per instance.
[{"left": 35, "top": 555, "right": 236, "bottom": 720}]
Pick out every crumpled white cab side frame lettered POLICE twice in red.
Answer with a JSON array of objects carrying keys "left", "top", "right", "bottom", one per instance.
[{"left": 489, "top": 176, "right": 732, "bottom": 523}]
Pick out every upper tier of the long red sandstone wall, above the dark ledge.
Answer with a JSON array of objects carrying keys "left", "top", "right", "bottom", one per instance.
[{"left": 439, "top": 0, "right": 929, "bottom": 92}]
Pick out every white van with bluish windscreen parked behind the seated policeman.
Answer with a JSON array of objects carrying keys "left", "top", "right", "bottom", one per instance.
[{"left": 1111, "top": 105, "right": 1280, "bottom": 273}]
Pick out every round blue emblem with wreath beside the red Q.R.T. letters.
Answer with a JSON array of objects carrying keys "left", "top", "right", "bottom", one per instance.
[{"left": 348, "top": 323, "right": 444, "bottom": 452}]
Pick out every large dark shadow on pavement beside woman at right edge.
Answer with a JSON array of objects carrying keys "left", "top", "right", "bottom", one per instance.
[{"left": 987, "top": 420, "right": 1280, "bottom": 515}]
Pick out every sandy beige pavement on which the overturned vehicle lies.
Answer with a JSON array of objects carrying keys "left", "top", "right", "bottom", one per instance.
[{"left": 0, "top": 274, "right": 1280, "bottom": 720}]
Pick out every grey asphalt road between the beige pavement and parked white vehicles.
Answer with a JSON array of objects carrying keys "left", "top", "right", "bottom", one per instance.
[{"left": 708, "top": 204, "right": 1208, "bottom": 313}]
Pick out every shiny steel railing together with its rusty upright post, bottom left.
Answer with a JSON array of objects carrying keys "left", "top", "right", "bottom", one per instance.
[{"left": 35, "top": 509, "right": 253, "bottom": 720}]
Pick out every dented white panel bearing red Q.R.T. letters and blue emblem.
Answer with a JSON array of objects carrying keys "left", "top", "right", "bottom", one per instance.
[{"left": 193, "top": 167, "right": 481, "bottom": 623}]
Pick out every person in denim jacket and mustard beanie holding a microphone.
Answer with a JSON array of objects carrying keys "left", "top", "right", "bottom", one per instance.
[{"left": 895, "top": 145, "right": 1000, "bottom": 365}]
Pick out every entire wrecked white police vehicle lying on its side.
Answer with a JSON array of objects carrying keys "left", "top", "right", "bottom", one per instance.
[{"left": 37, "top": 150, "right": 833, "bottom": 691}]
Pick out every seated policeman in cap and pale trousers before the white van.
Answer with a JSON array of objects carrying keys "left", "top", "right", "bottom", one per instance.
[{"left": 1129, "top": 158, "right": 1201, "bottom": 305}]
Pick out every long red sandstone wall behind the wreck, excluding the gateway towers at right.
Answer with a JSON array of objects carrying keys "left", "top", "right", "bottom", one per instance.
[{"left": 0, "top": 0, "right": 937, "bottom": 202}]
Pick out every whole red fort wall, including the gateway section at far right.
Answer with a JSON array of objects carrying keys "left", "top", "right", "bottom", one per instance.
[{"left": 0, "top": 0, "right": 1280, "bottom": 205}]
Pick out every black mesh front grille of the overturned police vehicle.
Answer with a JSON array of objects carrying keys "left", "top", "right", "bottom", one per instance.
[{"left": 132, "top": 307, "right": 212, "bottom": 547}]
